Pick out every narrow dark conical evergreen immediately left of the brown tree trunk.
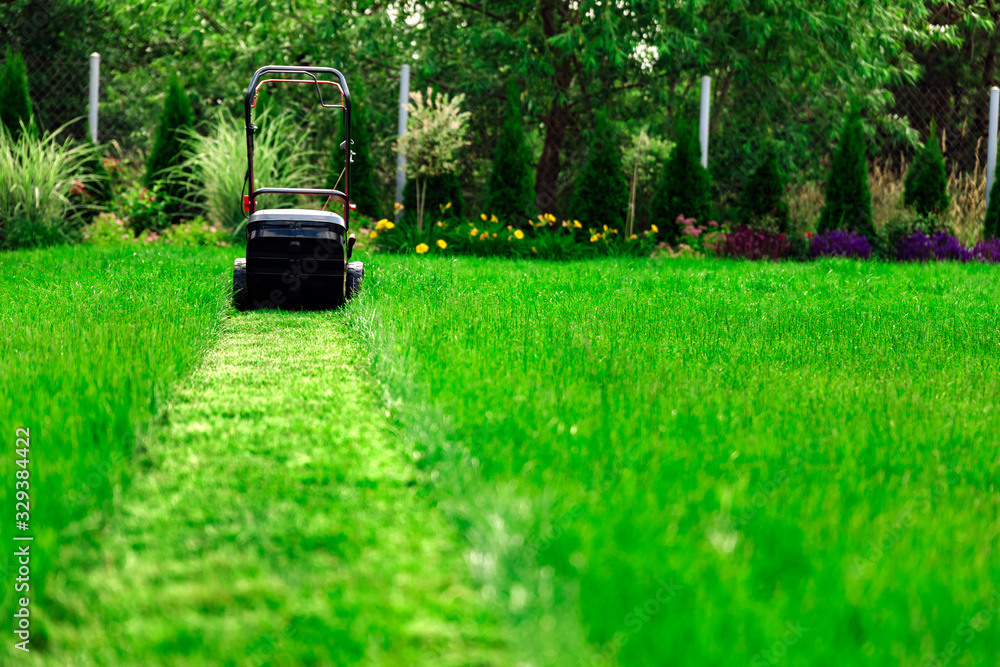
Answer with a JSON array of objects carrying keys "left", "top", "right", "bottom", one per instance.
[{"left": 484, "top": 81, "right": 534, "bottom": 227}]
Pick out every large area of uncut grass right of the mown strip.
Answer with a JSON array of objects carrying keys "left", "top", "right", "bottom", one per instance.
[{"left": 351, "top": 256, "right": 1000, "bottom": 666}]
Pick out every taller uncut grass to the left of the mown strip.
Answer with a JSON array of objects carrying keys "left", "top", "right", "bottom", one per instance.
[{"left": 0, "top": 246, "right": 232, "bottom": 632}]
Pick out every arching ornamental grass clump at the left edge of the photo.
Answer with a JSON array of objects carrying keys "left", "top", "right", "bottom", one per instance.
[{"left": 0, "top": 126, "right": 92, "bottom": 248}]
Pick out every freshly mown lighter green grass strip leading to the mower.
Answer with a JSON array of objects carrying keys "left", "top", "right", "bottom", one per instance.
[{"left": 39, "top": 311, "right": 507, "bottom": 666}]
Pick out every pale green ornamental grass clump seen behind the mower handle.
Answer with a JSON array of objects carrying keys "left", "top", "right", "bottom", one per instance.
[{"left": 176, "top": 109, "right": 321, "bottom": 237}]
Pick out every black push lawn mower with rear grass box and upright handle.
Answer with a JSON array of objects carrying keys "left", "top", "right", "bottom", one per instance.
[{"left": 233, "top": 65, "right": 364, "bottom": 310}]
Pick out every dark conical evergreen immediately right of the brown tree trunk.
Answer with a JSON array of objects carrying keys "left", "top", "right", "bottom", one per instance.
[{"left": 570, "top": 111, "right": 629, "bottom": 231}]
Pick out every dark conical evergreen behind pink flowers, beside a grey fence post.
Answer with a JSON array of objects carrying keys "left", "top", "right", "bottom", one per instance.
[{"left": 652, "top": 120, "right": 712, "bottom": 243}]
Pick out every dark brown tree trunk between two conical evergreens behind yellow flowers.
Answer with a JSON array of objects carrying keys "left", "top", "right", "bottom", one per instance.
[{"left": 535, "top": 0, "right": 573, "bottom": 213}]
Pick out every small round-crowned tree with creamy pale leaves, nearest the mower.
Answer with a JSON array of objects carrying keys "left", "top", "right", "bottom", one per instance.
[{"left": 396, "top": 88, "right": 469, "bottom": 231}]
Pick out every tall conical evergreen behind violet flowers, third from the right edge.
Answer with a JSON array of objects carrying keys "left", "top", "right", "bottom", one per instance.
[{"left": 818, "top": 104, "right": 875, "bottom": 239}]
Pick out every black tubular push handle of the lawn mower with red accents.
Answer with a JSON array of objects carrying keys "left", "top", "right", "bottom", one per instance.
[{"left": 243, "top": 65, "right": 353, "bottom": 227}]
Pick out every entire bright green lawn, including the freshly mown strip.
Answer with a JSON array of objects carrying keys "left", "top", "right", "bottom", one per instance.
[{"left": 0, "top": 248, "right": 1000, "bottom": 667}]
